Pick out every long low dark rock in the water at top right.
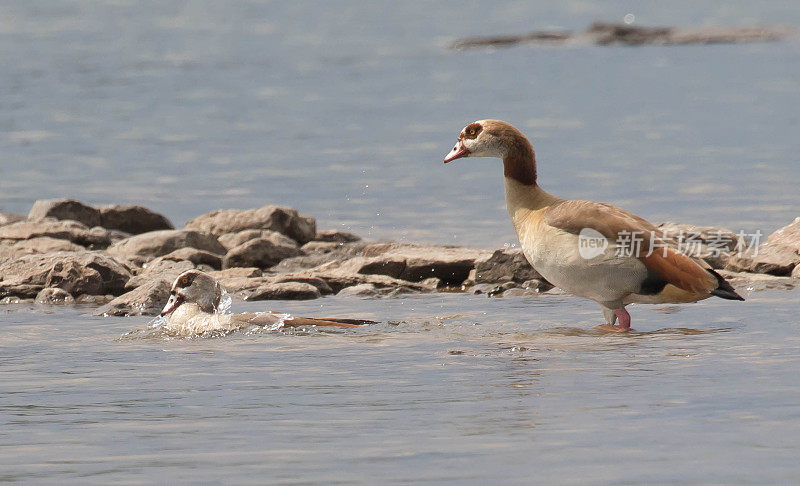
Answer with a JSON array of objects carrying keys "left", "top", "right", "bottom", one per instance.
[{"left": 450, "top": 22, "right": 796, "bottom": 49}]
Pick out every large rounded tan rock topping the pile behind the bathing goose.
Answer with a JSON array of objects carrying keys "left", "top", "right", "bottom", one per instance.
[{"left": 186, "top": 205, "right": 317, "bottom": 244}]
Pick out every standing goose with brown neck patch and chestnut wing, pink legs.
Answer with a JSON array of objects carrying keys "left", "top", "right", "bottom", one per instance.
[{"left": 444, "top": 120, "right": 744, "bottom": 332}]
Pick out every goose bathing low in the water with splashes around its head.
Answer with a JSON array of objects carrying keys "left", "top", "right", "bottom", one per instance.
[{"left": 161, "top": 270, "right": 372, "bottom": 336}]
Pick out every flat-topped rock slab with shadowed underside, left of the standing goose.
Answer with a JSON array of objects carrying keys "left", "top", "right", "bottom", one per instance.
[{"left": 359, "top": 243, "right": 491, "bottom": 285}]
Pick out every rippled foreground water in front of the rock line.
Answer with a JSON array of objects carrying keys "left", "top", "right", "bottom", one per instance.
[{"left": 0, "top": 291, "right": 800, "bottom": 484}]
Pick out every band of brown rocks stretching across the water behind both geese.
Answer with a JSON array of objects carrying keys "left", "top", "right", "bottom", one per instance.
[{"left": 0, "top": 199, "right": 800, "bottom": 316}]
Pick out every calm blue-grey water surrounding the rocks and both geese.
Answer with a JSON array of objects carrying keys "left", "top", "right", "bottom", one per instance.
[{"left": 0, "top": 0, "right": 800, "bottom": 484}]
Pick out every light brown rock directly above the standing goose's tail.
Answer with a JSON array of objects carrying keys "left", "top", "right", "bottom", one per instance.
[{"left": 656, "top": 223, "right": 745, "bottom": 269}]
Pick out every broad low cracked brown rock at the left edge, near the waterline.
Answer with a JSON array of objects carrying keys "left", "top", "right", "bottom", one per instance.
[{"left": 0, "top": 251, "right": 131, "bottom": 297}]
